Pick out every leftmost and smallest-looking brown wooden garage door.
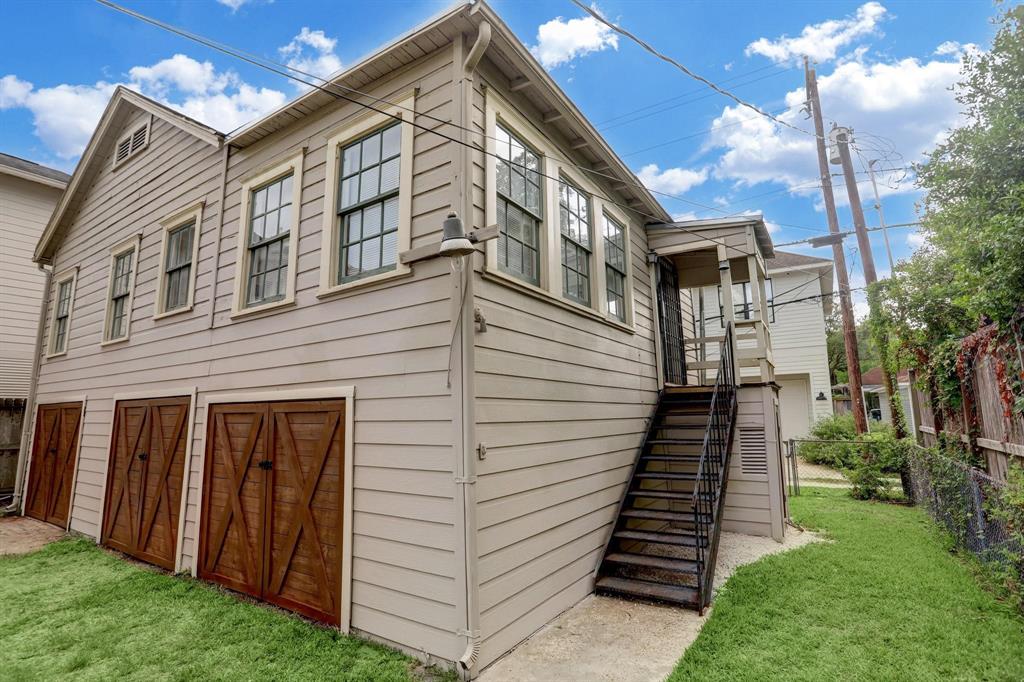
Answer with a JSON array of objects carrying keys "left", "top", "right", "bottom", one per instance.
[{"left": 25, "top": 402, "right": 82, "bottom": 527}]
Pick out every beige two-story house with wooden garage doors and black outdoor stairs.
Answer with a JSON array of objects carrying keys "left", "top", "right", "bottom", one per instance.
[{"left": 25, "top": 2, "right": 785, "bottom": 677}]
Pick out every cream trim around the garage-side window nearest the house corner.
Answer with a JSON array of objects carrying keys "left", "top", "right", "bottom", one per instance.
[{"left": 316, "top": 91, "right": 416, "bottom": 297}]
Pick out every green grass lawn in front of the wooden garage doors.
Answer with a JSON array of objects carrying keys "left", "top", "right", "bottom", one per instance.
[{"left": 0, "top": 540, "right": 448, "bottom": 682}]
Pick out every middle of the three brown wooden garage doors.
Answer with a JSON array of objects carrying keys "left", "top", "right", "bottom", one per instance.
[{"left": 101, "top": 397, "right": 189, "bottom": 570}]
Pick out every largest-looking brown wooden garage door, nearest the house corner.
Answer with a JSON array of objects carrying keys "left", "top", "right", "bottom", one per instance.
[{"left": 199, "top": 400, "right": 345, "bottom": 625}]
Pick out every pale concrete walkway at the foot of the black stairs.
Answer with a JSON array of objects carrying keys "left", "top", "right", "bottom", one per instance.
[{"left": 479, "top": 527, "right": 819, "bottom": 682}]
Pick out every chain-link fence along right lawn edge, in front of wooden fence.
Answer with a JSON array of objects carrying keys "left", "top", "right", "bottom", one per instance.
[{"left": 909, "top": 447, "right": 1024, "bottom": 584}]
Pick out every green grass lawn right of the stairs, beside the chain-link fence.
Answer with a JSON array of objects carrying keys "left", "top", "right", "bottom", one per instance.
[{"left": 670, "top": 488, "right": 1024, "bottom": 682}]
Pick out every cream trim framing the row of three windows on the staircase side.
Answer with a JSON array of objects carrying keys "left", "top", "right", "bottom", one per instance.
[{"left": 483, "top": 88, "right": 636, "bottom": 332}]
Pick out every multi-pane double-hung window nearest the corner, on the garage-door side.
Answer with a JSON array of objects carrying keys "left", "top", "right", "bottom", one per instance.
[{"left": 335, "top": 123, "right": 401, "bottom": 284}]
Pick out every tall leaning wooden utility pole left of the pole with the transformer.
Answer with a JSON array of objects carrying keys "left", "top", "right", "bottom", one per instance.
[{"left": 804, "top": 57, "right": 867, "bottom": 433}]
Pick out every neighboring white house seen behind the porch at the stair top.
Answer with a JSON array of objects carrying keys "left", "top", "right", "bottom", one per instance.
[{"left": 691, "top": 251, "right": 833, "bottom": 440}]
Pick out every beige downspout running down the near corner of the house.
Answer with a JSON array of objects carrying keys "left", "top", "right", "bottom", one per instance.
[{"left": 456, "top": 22, "right": 490, "bottom": 679}]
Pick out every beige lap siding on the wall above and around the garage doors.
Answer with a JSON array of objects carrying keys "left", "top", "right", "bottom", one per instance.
[{"left": 32, "top": 49, "right": 465, "bottom": 660}]
